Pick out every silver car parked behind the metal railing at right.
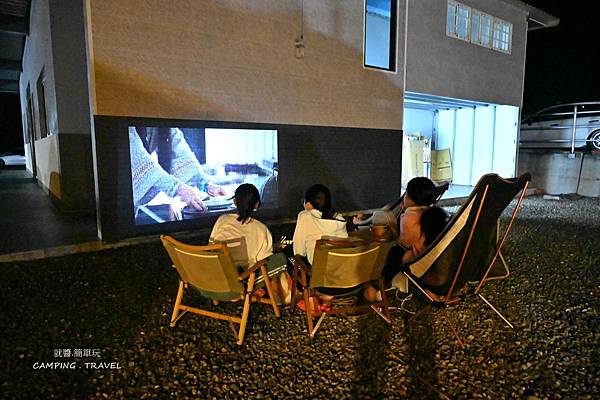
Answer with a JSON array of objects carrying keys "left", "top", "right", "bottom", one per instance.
[{"left": 519, "top": 102, "right": 600, "bottom": 151}]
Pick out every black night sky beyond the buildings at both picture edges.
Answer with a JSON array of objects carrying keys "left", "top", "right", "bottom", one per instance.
[{"left": 0, "top": 0, "right": 600, "bottom": 151}]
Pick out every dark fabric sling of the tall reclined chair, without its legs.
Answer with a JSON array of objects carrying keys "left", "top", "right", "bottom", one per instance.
[{"left": 408, "top": 173, "right": 531, "bottom": 297}]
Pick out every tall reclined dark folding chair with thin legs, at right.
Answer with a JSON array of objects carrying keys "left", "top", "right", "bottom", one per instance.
[{"left": 392, "top": 173, "right": 531, "bottom": 348}]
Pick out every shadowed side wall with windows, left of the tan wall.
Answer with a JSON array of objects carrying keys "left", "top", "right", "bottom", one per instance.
[{"left": 20, "top": 0, "right": 94, "bottom": 211}]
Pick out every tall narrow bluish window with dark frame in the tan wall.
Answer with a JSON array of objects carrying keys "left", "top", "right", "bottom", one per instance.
[{"left": 363, "top": 0, "right": 398, "bottom": 71}]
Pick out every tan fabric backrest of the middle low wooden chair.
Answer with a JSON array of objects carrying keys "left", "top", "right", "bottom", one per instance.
[{"left": 310, "top": 239, "right": 391, "bottom": 288}]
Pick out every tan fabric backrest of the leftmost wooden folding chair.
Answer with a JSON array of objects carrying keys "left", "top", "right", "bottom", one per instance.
[{"left": 161, "top": 235, "right": 244, "bottom": 297}]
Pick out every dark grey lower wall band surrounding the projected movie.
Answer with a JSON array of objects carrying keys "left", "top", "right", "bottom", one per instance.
[{"left": 94, "top": 116, "right": 402, "bottom": 241}]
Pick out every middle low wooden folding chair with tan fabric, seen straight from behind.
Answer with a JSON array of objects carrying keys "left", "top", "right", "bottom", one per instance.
[{"left": 291, "top": 239, "right": 392, "bottom": 339}]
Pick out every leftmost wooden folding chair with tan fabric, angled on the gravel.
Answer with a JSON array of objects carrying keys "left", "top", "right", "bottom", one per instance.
[{"left": 160, "top": 235, "right": 285, "bottom": 345}]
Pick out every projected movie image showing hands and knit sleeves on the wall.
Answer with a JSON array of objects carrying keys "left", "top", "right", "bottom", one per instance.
[{"left": 129, "top": 126, "right": 278, "bottom": 225}]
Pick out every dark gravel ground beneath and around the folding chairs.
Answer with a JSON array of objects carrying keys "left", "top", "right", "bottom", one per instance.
[{"left": 0, "top": 197, "right": 600, "bottom": 400}]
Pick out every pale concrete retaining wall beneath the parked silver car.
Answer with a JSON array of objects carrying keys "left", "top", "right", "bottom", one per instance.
[{"left": 518, "top": 150, "right": 600, "bottom": 197}]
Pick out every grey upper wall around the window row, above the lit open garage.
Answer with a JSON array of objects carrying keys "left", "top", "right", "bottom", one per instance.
[{"left": 403, "top": 0, "right": 527, "bottom": 107}]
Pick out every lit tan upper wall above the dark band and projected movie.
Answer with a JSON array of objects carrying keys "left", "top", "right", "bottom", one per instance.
[{"left": 90, "top": 0, "right": 403, "bottom": 129}]
